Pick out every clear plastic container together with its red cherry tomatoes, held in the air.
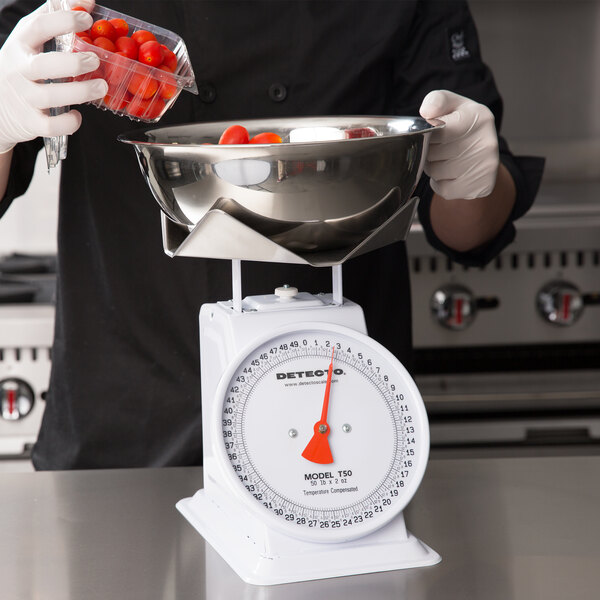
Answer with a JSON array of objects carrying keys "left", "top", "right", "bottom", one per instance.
[{"left": 72, "top": 5, "right": 198, "bottom": 123}]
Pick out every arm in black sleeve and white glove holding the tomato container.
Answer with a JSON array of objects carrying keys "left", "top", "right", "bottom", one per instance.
[{"left": 0, "top": 0, "right": 107, "bottom": 217}]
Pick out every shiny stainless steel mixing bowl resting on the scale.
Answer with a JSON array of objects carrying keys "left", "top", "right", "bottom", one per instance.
[{"left": 119, "top": 116, "right": 443, "bottom": 253}]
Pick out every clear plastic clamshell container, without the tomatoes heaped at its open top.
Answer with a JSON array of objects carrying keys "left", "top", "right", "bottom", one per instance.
[{"left": 72, "top": 4, "right": 198, "bottom": 123}]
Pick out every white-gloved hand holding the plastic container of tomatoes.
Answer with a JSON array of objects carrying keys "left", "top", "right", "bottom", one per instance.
[{"left": 0, "top": 4, "right": 108, "bottom": 153}]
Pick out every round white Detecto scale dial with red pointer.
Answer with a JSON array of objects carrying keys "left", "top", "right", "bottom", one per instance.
[{"left": 213, "top": 323, "right": 429, "bottom": 542}]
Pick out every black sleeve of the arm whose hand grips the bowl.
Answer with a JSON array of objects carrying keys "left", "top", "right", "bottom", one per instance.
[{"left": 395, "top": 0, "right": 544, "bottom": 266}]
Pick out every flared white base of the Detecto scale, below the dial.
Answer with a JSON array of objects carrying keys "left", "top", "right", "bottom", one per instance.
[{"left": 177, "top": 489, "right": 441, "bottom": 585}]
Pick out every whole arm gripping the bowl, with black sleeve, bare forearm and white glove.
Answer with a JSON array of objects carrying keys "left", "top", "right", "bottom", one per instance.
[{"left": 394, "top": 0, "right": 543, "bottom": 267}]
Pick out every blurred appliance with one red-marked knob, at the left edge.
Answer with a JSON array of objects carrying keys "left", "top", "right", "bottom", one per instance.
[{"left": 0, "top": 254, "right": 56, "bottom": 460}]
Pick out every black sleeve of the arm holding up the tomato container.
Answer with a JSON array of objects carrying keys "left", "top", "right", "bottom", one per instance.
[{"left": 0, "top": 0, "right": 43, "bottom": 217}]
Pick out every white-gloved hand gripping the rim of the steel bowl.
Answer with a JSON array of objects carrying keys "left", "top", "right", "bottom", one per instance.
[{"left": 419, "top": 90, "right": 500, "bottom": 200}]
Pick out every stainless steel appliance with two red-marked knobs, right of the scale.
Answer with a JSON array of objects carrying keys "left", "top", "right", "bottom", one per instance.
[{"left": 408, "top": 182, "right": 600, "bottom": 447}]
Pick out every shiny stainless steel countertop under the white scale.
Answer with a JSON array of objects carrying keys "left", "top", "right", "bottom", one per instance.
[{"left": 0, "top": 456, "right": 600, "bottom": 600}]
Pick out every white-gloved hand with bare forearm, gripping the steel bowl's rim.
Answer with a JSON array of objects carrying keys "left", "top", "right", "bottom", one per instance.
[{"left": 420, "top": 90, "right": 517, "bottom": 252}]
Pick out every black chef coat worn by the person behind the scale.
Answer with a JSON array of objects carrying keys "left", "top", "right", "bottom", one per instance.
[{"left": 0, "top": 0, "right": 541, "bottom": 469}]
